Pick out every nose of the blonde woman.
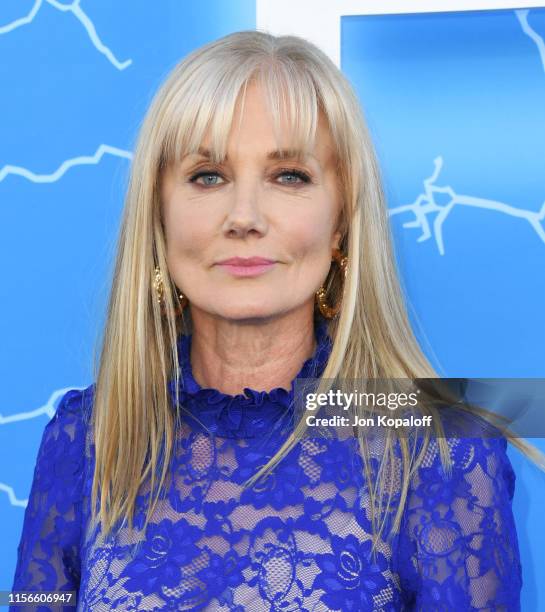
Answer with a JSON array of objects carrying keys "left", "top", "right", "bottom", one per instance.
[{"left": 219, "top": 179, "right": 267, "bottom": 238}]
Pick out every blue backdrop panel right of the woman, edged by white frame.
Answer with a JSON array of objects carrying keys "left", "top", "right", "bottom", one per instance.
[{"left": 341, "top": 8, "right": 545, "bottom": 611}]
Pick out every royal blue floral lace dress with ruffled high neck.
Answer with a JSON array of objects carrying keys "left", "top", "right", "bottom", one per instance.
[{"left": 11, "top": 323, "right": 522, "bottom": 612}]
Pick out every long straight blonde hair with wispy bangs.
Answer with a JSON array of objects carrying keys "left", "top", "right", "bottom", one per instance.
[{"left": 91, "top": 31, "right": 545, "bottom": 535}]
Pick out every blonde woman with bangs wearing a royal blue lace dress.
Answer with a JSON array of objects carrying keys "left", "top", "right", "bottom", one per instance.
[{"left": 13, "top": 31, "right": 541, "bottom": 612}]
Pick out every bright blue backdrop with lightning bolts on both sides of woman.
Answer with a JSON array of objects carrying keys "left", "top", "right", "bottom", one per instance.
[{"left": 0, "top": 0, "right": 545, "bottom": 611}]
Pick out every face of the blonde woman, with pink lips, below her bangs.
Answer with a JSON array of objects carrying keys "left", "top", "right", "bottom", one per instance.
[{"left": 161, "top": 85, "right": 341, "bottom": 320}]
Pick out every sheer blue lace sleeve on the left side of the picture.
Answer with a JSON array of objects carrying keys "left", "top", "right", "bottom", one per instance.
[{"left": 10, "top": 390, "right": 86, "bottom": 611}]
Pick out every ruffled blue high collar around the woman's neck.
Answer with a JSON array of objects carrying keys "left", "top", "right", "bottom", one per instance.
[{"left": 169, "top": 317, "right": 332, "bottom": 438}]
